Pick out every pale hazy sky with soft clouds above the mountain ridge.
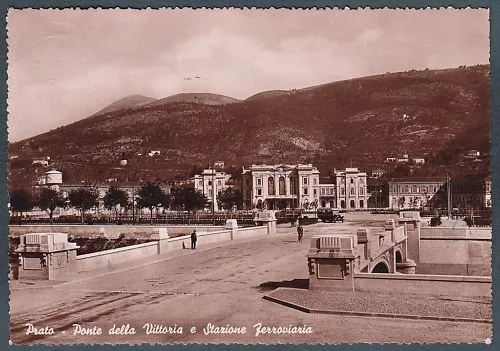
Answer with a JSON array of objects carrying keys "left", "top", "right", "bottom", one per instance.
[{"left": 7, "top": 9, "right": 489, "bottom": 141}]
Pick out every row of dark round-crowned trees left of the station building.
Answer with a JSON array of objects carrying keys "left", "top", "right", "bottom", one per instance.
[{"left": 10, "top": 183, "right": 243, "bottom": 224}]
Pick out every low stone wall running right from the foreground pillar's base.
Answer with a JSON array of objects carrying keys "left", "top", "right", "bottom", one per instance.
[{"left": 354, "top": 273, "right": 491, "bottom": 296}]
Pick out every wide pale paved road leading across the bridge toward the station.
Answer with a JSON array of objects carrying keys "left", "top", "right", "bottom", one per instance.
[{"left": 11, "top": 223, "right": 491, "bottom": 344}]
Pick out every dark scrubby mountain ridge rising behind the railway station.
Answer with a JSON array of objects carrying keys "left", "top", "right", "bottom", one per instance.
[{"left": 9, "top": 65, "right": 489, "bottom": 188}]
